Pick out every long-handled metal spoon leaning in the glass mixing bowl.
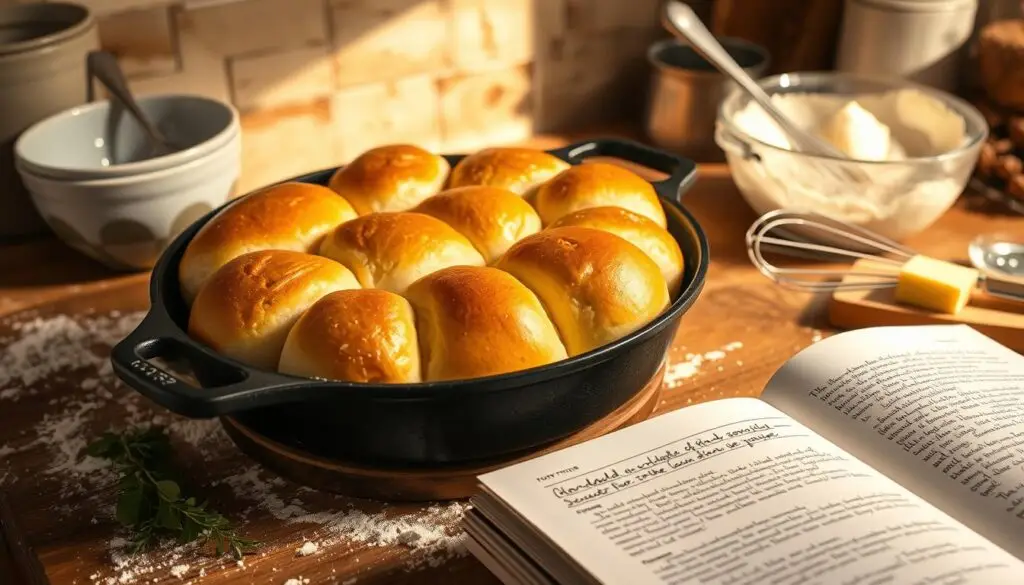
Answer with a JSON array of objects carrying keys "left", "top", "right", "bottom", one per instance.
[{"left": 663, "top": 0, "right": 849, "bottom": 160}]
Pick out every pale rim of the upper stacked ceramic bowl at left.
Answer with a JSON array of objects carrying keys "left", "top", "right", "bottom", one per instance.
[{"left": 14, "top": 93, "right": 241, "bottom": 180}]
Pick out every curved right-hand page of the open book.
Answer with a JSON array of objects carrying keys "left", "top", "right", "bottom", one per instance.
[{"left": 762, "top": 325, "right": 1024, "bottom": 558}]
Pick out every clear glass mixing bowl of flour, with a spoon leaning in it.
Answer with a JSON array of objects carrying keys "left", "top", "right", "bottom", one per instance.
[{"left": 715, "top": 73, "right": 988, "bottom": 240}]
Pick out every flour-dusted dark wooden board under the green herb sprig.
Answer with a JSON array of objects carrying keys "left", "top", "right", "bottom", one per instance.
[{"left": 0, "top": 283, "right": 495, "bottom": 585}]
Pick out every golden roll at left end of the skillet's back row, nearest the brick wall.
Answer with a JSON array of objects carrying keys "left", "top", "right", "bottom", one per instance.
[{"left": 329, "top": 144, "right": 450, "bottom": 215}]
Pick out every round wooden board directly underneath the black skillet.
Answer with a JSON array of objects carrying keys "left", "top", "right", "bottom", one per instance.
[{"left": 221, "top": 364, "right": 666, "bottom": 502}]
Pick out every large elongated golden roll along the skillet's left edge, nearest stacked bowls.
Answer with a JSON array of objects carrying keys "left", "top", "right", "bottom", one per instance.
[{"left": 178, "top": 182, "right": 356, "bottom": 302}]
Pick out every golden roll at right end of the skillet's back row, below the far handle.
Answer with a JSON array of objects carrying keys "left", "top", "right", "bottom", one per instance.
[{"left": 534, "top": 163, "right": 667, "bottom": 227}]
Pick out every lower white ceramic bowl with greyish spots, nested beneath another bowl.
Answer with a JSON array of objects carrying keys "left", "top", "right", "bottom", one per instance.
[{"left": 17, "top": 132, "right": 242, "bottom": 270}]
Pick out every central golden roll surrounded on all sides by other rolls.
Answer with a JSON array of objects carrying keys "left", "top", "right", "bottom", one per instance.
[{"left": 321, "top": 212, "right": 484, "bottom": 294}]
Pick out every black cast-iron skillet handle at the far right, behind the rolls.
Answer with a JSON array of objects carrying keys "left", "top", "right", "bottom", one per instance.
[{"left": 548, "top": 138, "right": 697, "bottom": 201}]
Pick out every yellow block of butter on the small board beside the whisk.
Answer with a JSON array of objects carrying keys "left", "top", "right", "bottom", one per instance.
[{"left": 896, "top": 256, "right": 979, "bottom": 315}]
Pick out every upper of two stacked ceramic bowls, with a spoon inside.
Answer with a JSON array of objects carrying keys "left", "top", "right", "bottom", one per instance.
[{"left": 14, "top": 95, "right": 240, "bottom": 180}]
